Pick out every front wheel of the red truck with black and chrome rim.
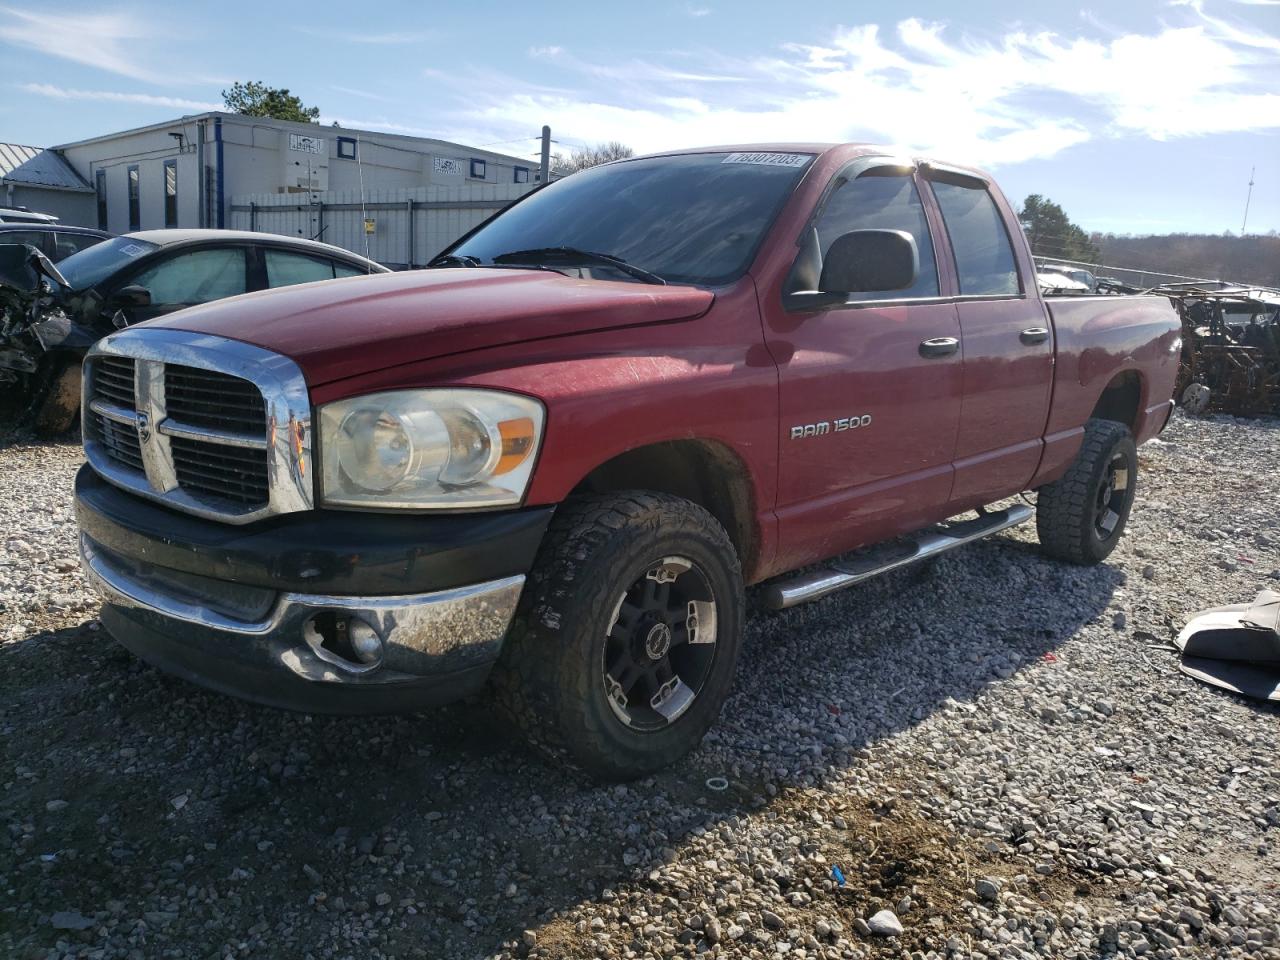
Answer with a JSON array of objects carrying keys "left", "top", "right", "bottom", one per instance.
[{"left": 492, "top": 492, "right": 745, "bottom": 780}]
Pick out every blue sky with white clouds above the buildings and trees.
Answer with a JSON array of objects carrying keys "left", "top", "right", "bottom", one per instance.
[{"left": 0, "top": 0, "right": 1280, "bottom": 234}]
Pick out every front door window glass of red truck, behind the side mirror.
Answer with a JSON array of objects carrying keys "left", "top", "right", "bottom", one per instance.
[{"left": 817, "top": 174, "right": 938, "bottom": 300}]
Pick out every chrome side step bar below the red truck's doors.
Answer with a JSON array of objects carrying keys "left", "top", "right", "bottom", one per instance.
[{"left": 764, "top": 503, "right": 1036, "bottom": 611}]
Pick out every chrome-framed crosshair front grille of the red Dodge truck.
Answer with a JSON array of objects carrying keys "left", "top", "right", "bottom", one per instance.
[{"left": 83, "top": 329, "right": 312, "bottom": 524}]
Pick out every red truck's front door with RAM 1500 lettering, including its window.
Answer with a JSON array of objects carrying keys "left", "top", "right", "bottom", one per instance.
[{"left": 763, "top": 159, "right": 961, "bottom": 567}]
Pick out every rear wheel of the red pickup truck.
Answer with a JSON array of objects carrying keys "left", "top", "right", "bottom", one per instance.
[{"left": 1036, "top": 420, "right": 1138, "bottom": 564}]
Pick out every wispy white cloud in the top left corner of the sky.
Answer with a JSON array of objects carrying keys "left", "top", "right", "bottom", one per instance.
[{"left": 0, "top": 6, "right": 157, "bottom": 81}]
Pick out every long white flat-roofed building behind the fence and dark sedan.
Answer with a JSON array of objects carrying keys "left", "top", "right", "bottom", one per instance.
[{"left": 54, "top": 113, "right": 539, "bottom": 233}]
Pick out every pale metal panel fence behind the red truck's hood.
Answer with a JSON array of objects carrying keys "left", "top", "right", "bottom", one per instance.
[{"left": 229, "top": 183, "right": 536, "bottom": 270}]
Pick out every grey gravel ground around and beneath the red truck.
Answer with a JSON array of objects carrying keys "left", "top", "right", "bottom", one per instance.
[{"left": 0, "top": 416, "right": 1280, "bottom": 957}]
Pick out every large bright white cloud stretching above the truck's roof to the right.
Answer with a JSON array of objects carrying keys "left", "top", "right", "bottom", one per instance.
[{"left": 460, "top": 10, "right": 1280, "bottom": 165}]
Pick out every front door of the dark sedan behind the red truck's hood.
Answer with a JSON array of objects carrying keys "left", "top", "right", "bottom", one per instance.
[{"left": 115, "top": 246, "right": 248, "bottom": 325}]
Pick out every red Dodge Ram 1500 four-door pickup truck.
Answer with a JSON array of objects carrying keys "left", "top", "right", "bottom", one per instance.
[{"left": 76, "top": 145, "right": 1180, "bottom": 778}]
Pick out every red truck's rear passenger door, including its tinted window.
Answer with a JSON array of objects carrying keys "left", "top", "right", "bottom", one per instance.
[{"left": 924, "top": 168, "right": 1053, "bottom": 508}]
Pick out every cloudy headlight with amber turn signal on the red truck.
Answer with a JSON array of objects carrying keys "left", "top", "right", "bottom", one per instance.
[{"left": 320, "top": 389, "right": 543, "bottom": 509}]
